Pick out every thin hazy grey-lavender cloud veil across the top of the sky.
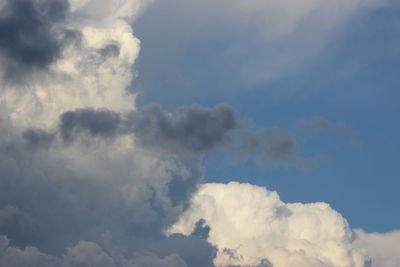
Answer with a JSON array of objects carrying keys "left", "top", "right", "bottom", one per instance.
[{"left": 134, "top": 0, "right": 386, "bottom": 106}]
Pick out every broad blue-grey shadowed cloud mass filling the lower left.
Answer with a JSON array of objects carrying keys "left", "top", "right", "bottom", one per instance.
[{"left": 0, "top": 107, "right": 220, "bottom": 267}]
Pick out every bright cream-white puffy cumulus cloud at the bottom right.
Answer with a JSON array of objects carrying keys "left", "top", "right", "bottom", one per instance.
[{"left": 169, "top": 182, "right": 368, "bottom": 267}]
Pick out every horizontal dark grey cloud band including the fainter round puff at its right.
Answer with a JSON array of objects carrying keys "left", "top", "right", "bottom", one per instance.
[{"left": 49, "top": 104, "right": 297, "bottom": 164}]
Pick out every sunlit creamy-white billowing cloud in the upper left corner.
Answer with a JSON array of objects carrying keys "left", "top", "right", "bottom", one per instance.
[{"left": 0, "top": 0, "right": 151, "bottom": 128}]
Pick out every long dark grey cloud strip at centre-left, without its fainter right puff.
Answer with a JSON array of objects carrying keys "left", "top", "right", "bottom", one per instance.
[{"left": 59, "top": 104, "right": 238, "bottom": 153}]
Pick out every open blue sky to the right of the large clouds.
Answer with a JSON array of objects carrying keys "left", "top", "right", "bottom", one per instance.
[{"left": 134, "top": 1, "right": 400, "bottom": 232}]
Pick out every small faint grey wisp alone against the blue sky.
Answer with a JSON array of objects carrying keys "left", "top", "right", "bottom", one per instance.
[{"left": 302, "top": 117, "right": 357, "bottom": 144}]
